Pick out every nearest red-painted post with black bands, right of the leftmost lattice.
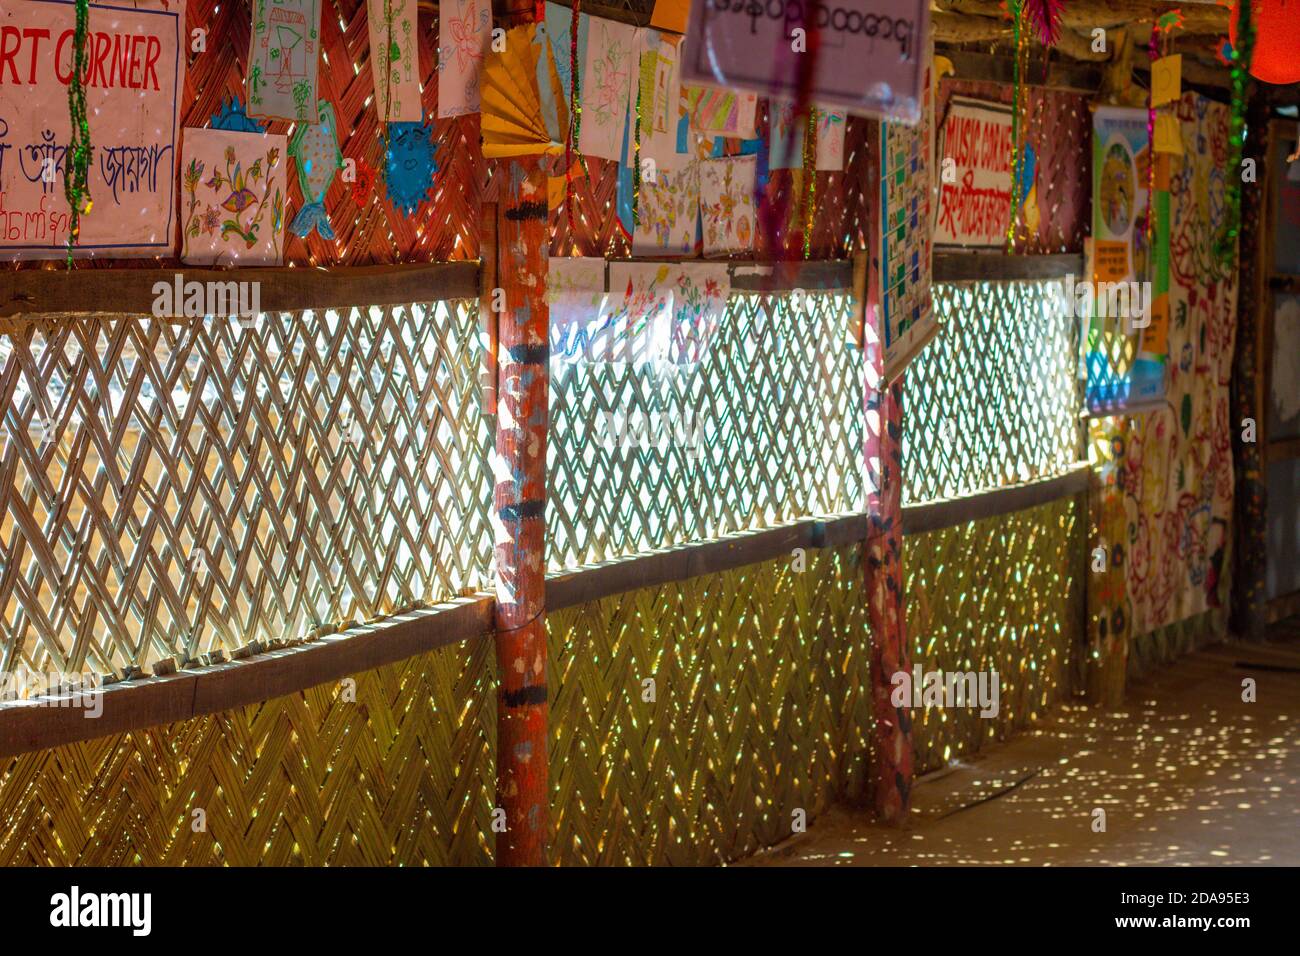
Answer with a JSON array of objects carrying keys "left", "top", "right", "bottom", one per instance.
[{"left": 493, "top": 156, "right": 550, "bottom": 866}]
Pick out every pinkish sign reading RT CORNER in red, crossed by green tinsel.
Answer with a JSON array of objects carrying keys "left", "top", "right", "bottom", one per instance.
[{"left": 0, "top": 0, "right": 185, "bottom": 260}]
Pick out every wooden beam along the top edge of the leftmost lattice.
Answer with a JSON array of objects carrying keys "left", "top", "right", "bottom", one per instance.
[{"left": 0, "top": 261, "right": 478, "bottom": 320}]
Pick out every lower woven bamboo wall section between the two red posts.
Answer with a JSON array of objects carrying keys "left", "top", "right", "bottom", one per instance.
[{"left": 547, "top": 548, "right": 871, "bottom": 865}]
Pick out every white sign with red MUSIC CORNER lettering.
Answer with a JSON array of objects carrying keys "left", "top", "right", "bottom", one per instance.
[{"left": 935, "top": 96, "right": 1013, "bottom": 248}]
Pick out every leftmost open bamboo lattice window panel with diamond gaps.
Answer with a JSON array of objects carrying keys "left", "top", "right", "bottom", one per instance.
[{"left": 0, "top": 302, "right": 491, "bottom": 674}]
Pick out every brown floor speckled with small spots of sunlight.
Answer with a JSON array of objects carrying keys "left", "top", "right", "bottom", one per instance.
[{"left": 740, "top": 619, "right": 1300, "bottom": 866}]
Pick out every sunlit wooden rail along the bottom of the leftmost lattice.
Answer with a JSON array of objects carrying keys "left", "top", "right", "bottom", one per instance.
[{"left": 0, "top": 594, "right": 493, "bottom": 758}]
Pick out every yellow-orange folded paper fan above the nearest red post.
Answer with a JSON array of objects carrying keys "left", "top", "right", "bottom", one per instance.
[{"left": 481, "top": 23, "right": 568, "bottom": 159}]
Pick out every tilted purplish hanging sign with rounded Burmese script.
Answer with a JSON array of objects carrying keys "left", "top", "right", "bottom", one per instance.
[{"left": 681, "top": 0, "right": 930, "bottom": 124}]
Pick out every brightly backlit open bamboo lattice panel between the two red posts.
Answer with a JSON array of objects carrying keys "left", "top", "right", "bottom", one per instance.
[{"left": 547, "top": 295, "right": 866, "bottom": 568}]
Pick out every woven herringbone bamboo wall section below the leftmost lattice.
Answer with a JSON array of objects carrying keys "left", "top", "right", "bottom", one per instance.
[{"left": 0, "top": 636, "right": 495, "bottom": 866}]
